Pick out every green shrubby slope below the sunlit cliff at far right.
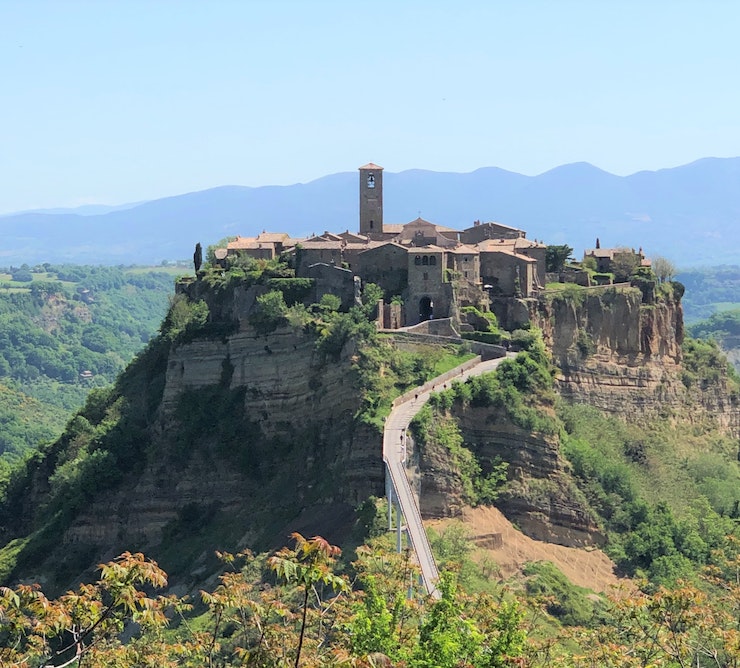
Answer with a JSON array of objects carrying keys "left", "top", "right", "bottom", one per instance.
[{"left": 559, "top": 406, "right": 740, "bottom": 583}]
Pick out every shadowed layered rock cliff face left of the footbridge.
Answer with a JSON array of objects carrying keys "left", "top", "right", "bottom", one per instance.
[{"left": 64, "top": 327, "right": 384, "bottom": 558}]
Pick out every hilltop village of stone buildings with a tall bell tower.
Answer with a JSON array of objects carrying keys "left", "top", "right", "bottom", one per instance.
[{"left": 215, "top": 163, "right": 649, "bottom": 328}]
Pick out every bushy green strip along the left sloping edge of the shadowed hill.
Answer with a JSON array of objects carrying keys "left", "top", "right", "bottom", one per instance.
[{"left": 0, "top": 338, "right": 169, "bottom": 580}]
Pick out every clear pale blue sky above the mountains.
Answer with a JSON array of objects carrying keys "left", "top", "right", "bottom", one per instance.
[{"left": 0, "top": 0, "right": 740, "bottom": 213}]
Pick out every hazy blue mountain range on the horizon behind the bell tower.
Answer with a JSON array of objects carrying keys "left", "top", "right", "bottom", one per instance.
[{"left": 0, "top": 158, "right": 740, "bottom": 267}]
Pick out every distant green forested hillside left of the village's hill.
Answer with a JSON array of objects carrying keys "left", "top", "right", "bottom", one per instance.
[{"left": 0, "top": 264, "right": 176, "bottom": 461}]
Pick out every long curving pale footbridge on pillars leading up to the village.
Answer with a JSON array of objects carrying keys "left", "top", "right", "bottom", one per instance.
[{"left": 383, "top": 348, "right": 506, "bottom": 598}]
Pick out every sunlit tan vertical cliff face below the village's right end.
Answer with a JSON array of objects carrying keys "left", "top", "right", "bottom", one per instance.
[{"left": 530, "top": 288, "right": 740, "bottom": 437}]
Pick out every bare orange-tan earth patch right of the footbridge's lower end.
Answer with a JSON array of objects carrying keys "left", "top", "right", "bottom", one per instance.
[{"left": 425, "top": 508, "right": 625, "bottom": 592}]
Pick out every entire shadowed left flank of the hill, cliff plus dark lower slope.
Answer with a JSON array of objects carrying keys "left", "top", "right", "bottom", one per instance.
[{"left": 3, "top": 326, "right": 384, "bottom": 583}]
